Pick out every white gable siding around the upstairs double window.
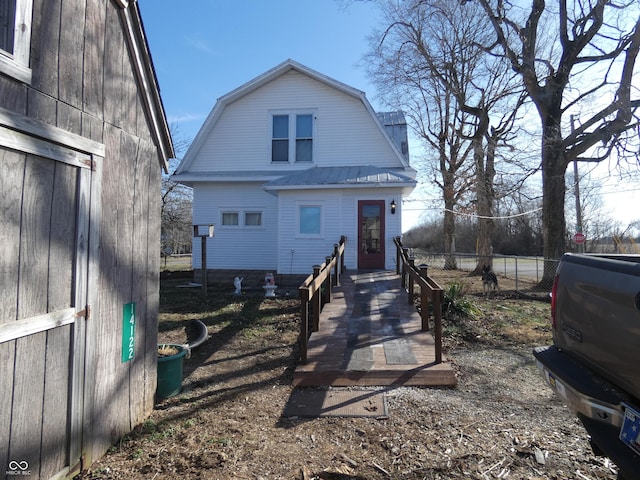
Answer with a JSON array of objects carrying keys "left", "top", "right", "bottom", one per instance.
[{"left": 189, "top": 70, "right": 401, "bottom": 172}]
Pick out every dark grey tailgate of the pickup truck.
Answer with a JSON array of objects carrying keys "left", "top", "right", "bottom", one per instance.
[{"left": 554, "top": 255, "right": 640, "bottom": 399}]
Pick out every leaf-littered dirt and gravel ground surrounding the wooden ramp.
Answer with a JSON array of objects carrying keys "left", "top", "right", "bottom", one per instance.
[{"left": 75, "top": 270, "right": 616, "bottom": 480}]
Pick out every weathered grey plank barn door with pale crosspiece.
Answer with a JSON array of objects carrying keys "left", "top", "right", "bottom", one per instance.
[{"left": 0, "top": 144, "right": 95, "bottom": 479}]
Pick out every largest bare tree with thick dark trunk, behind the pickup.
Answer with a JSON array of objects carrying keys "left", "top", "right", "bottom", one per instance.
[{"left": 472, "top": 0, "right": 640, "bottom": 281}]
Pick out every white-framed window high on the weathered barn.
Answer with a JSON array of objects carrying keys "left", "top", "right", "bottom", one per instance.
[{"left": 0, "top": 0, "right": 33, "bottom": 83}]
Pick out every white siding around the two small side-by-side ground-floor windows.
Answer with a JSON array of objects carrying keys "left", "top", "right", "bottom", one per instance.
[{"left": 193, "top": 183, "right": 278, "bottom": 271}]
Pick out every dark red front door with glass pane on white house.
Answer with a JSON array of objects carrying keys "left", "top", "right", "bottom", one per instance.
[{"left": 358, "top": 200, "right": 384, "bottom": 269}]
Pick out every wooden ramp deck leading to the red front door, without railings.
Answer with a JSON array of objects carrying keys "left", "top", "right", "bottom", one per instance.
[{"left": 293, "top": 271, "right": 456, "bottom": 386}]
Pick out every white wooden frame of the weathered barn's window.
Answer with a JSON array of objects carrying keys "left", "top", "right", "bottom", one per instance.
[{"left": 0, "top": 0, "right": 33, "bottom": 84}]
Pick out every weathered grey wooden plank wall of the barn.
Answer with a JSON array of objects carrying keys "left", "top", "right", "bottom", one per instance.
[{"left": 0, "top": 0, "right": 161, "bottom": 479}]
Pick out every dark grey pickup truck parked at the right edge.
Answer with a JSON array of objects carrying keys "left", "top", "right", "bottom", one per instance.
[{"left": 533, "top": 254, "right": 640, "bottom": 480}]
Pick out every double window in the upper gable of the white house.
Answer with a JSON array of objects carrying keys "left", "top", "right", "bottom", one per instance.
[{"left": 271, "top": 113, "right": 313, "bottom": 163}]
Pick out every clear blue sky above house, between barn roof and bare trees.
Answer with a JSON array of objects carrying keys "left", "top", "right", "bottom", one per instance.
[{"left": 138, "top": 0, "right": 377, "bottom": 150}]
